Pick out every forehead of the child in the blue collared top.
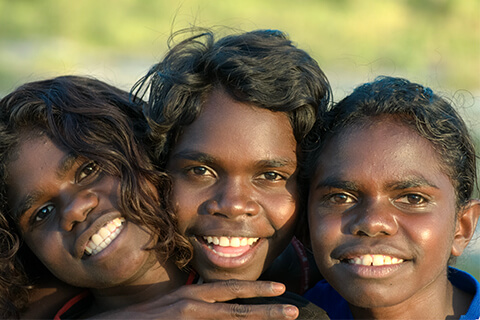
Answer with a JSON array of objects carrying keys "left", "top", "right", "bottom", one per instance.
[{"left": 317, "top": 118, "right": 445, "bottom": 184}]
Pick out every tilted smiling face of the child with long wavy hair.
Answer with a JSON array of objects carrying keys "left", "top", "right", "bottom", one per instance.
[{"left": 7, "top": 136, "right": 160, "bottom": 288}]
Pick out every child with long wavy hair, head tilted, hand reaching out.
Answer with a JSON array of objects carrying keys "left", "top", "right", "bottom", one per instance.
[{"left": 0, "top": 76, "right": 308, "bottom": 319}]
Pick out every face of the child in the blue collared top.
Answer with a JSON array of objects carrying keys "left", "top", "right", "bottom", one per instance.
[{"left": 308, "top": 119, "right": 462, "bottom": 308}]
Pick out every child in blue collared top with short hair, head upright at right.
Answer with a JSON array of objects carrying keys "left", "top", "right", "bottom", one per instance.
[{"left": 304, "top": 77, "right": 480, "bottom": 319}]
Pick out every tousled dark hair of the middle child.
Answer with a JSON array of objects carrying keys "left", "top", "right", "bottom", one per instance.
[{"left": 132, "top": 28, "right": 331, "bottom": 168}]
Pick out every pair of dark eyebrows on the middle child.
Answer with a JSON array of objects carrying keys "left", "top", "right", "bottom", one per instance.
[{"left": 171, "top": 150, "right": 297, "bottom": 168}]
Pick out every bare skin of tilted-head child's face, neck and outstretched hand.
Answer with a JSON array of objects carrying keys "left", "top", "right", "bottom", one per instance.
[{"left": 14, "top": 136, "right": 298, "bottom": 319}]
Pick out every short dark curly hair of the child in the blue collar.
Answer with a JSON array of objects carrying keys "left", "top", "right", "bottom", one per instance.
[{"left": 302, "top": 76, "right": 476, "bottom": 209}]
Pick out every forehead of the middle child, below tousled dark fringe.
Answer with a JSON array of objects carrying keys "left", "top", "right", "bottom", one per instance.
[{"left": 175, "top": 90, "right": 296, "bottom": 160}]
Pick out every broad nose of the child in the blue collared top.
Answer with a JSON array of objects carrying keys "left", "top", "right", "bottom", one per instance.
[{"left": 349, "top": 199, "right": 398, "bottom": 237}]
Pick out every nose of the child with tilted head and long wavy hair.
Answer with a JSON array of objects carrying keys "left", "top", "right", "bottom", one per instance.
[{"left": 60, "top": 190, "right": 98, "bottom": 231}]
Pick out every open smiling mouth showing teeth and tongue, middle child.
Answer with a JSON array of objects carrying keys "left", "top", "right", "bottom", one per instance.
[{"left": 201, "top": 236, "right": 259, "bottom": 258}]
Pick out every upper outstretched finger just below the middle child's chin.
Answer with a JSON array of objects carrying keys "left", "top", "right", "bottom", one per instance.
[{"left": 171, "top": 280, "right": 285, "bottom": 302}]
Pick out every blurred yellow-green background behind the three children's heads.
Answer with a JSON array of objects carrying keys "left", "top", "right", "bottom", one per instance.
[{"left": 0, "top": 0, "right": 480, "bottom": 279}]
